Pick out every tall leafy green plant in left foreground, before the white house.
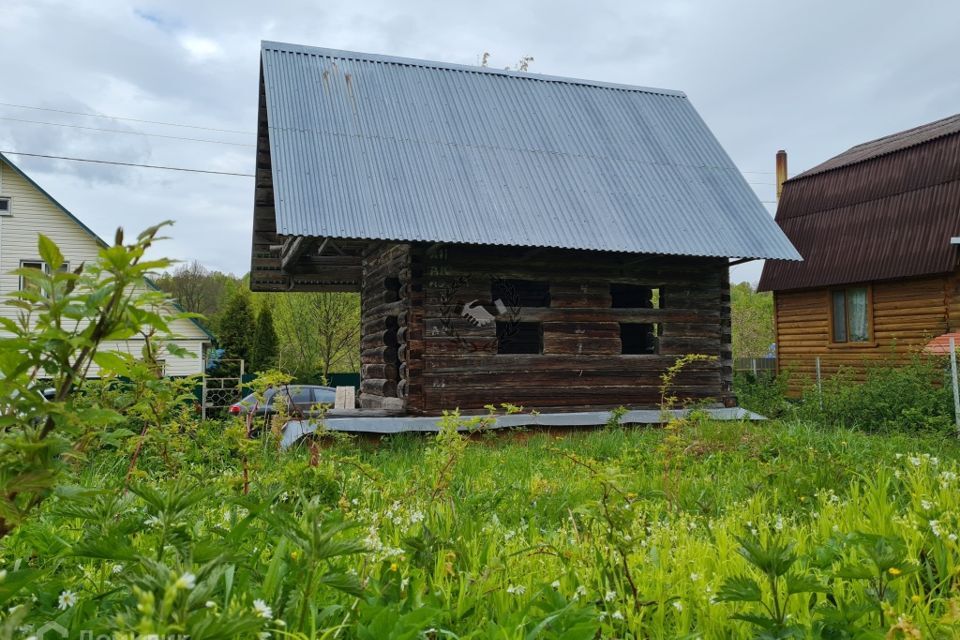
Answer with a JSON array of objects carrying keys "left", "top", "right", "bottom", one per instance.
[{"left": 0, "top": 225, "right": 188, "bottom": 538}]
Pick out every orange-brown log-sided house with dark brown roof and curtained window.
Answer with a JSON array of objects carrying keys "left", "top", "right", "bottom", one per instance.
[{"left": 759, "top": 115, "right": 960, "bottom": 393}]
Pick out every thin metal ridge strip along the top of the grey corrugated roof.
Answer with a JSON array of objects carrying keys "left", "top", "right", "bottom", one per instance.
[{"left": 260, "top": 40, "right": 687, "bottom": 99}]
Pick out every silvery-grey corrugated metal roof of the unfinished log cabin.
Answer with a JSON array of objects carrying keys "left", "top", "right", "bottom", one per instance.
[{"left": 262, "top": 42, "right": 799, "bottom": 259}]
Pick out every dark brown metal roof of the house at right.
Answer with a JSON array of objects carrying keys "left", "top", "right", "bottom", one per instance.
[{"left": 759, "top": 115, "right": 960, "bottom": 291}]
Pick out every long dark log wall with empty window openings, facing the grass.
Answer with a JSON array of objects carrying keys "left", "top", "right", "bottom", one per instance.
[{"left": 398, "top": 245, "right": 734, "bottom": 414}]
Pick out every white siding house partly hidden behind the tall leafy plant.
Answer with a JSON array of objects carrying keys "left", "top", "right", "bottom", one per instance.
[{"left": 0, "top": 154, "right": 212, "bottom": 376}]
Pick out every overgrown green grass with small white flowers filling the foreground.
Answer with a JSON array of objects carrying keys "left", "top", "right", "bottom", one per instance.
[{"left": 0, "top": 419, "right": 960, "bottom": 639}]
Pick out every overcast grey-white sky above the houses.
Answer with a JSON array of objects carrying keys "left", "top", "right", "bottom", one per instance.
[{"left": 0, "top": 0, "right": 960, "bottom": 281}]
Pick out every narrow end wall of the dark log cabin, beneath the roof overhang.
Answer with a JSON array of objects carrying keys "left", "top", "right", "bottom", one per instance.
[{"left": 360, "top": 244, "right": 410, "bottom": 411}]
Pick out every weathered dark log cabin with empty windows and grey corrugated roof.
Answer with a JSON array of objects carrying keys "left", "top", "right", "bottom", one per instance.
[{"left": 251, "top": 42, "right": 798, "bottom": 415}]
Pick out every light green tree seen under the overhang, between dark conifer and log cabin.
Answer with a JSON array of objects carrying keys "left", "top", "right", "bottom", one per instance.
[{"left": 274, "top": 293, "right": 360, "bottom": 378}]
